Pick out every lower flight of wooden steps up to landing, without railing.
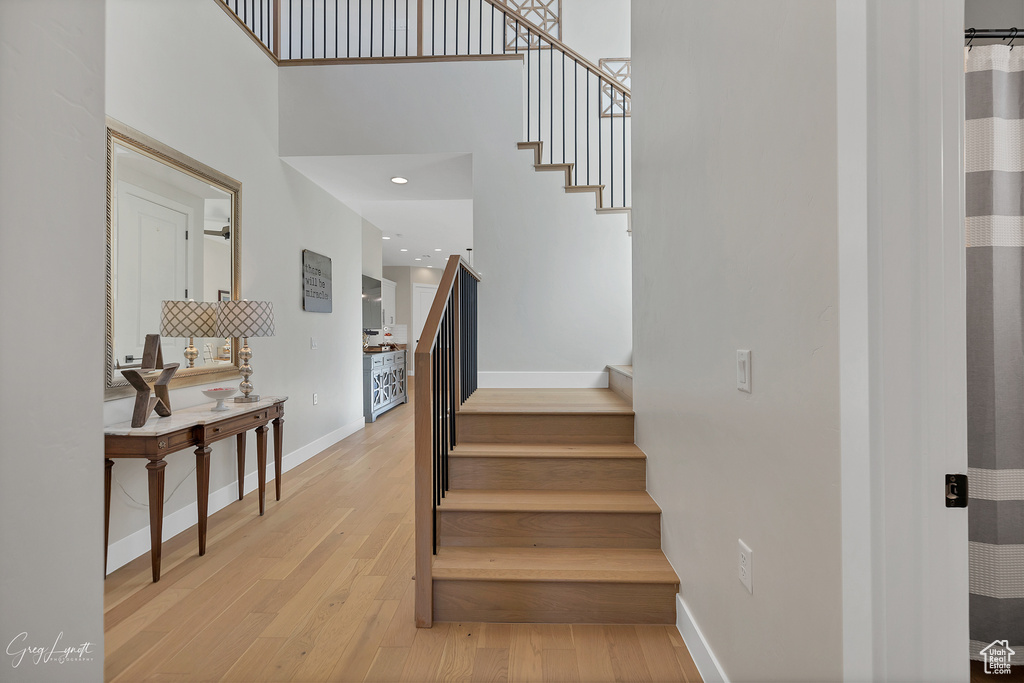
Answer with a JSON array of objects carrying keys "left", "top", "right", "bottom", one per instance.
[{"left": 432, "top": 389, "right": 679, "bottom": 624}]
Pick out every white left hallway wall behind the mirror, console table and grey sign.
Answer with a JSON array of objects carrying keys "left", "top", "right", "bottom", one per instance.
[{"left": 103, "top": 0, "right": 362, "bottom": 568}]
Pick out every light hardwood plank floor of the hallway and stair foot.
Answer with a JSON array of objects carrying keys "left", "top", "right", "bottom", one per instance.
[{"left": 104, "top": 391, "right": 700, "bottom": 683}]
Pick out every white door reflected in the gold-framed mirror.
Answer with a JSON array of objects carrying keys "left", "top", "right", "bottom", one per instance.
[{"left": 114, "top": 183, "right": 194, "bottom": 366}]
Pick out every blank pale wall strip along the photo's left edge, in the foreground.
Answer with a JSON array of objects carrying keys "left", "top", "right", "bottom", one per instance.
[{"left": 0, "top": 0, "right": 105, "bottom": 681}]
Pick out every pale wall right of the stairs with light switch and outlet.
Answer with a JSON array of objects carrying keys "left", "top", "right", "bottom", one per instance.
[{"left": 632, "top": 0, "right": 843, "bottom": 681}]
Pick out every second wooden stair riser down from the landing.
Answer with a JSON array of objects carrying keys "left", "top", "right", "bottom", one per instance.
[{"left": 449, "top": 457, "right": 647, "bottom": 490}]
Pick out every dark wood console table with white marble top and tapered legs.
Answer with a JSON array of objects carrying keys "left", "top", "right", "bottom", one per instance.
[{"left": 103, "top": 396, "right": 288, "bottom": 582}]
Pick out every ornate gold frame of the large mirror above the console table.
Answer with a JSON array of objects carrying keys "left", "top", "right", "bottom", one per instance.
[{"left": 103, "top": 117, "right": 242, "bottom": 400}]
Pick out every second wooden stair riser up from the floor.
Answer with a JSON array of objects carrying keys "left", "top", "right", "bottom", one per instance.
[{"left": 437, "top": 510, "right": 662, "bottom": 548}]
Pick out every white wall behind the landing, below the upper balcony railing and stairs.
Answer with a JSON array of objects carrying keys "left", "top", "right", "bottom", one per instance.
[{"left": 281, "top": 61, "right": 631, "bottom": 384}]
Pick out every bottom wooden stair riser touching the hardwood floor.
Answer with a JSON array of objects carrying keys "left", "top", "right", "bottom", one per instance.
[{"left": 433, "top": 581, "right": 679, "bottom": 624}]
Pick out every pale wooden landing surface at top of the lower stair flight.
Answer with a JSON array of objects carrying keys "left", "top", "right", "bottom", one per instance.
[{"left": 460, "top": 389, "right": 633, "bottom": 415}]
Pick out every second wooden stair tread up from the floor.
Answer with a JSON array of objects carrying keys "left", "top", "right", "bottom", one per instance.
[{"left": 438, "top": 489, "right": 662, "bottom": 514}]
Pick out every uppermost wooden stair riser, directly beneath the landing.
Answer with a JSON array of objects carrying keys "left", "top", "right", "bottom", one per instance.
[{"left": 458, "top": 413, "right": 633, "bottom": 443}]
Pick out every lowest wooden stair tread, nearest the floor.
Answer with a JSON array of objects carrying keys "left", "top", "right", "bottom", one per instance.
[{"left": 433, "top": 547, "right": 679, "bottom": 584}]
